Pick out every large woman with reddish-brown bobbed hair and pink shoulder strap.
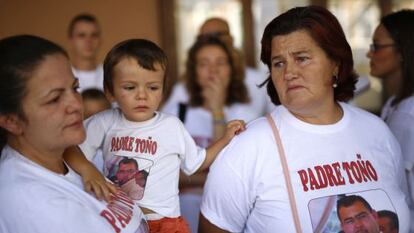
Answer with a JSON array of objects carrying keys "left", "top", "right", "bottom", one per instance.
[{"left": 200, "top": 6, "right": 409, "bottom": 233}]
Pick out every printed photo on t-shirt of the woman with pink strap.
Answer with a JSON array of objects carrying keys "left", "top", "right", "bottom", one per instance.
[{"left": 308, "top": 189, "right": 398, "bottom": 233}]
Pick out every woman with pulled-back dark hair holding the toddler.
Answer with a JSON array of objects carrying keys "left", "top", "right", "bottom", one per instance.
[{"left": 0, "top": 35, "right": 146, "bottom": 233}]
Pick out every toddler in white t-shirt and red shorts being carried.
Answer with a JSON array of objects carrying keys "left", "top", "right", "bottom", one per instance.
[{"left": 65, "top": 39, "right": 244, "bottom": 232}]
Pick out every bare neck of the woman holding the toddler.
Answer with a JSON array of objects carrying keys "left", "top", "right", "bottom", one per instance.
[{"left": 8, "top": 138, "right": 68, "bottom": 174}]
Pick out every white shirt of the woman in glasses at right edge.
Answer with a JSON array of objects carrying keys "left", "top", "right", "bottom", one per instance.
[{"left": 381, "top": 96, "right": 414, "bottom": 232}]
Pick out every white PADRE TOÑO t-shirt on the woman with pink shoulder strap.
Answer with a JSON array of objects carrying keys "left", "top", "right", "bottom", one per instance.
[{"left": 201, "top": 103, "right": 410, "bottom": 233}]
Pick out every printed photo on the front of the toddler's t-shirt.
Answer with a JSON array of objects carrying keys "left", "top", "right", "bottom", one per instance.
[{"left": 105, "top": 155, "right": 153, "bottom": 200}]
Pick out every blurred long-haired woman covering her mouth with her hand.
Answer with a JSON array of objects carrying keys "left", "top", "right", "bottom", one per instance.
[{"left": 162, "top": 35, "right": 261, "bottom": 232}]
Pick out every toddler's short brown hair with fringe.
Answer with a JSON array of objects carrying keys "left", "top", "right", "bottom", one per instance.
[{"left": 103, "top": 39, "right": 167, "bottom": 94}]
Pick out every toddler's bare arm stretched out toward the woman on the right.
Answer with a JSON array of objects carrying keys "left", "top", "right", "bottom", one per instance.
[{"left": 197, "top": 120, "right": 245, "bottom": 172}]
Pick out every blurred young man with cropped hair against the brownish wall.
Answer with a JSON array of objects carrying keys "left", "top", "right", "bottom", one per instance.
[{"left": 68, "top": 14, "right": 103, "bottom": 92}]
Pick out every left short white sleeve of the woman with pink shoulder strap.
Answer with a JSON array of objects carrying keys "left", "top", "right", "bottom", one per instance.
[{"left": 201, "top": 138, "right": 254, "bottom": 232}]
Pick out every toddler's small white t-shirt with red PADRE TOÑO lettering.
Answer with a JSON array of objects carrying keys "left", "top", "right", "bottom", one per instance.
[{"left": 80, "top": 109, "right": 206, "bottom": 217}]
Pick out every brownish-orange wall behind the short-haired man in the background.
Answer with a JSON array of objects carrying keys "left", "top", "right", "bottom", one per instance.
[{"left": 0, "top": 0, "right": 161, "bottom": 62}]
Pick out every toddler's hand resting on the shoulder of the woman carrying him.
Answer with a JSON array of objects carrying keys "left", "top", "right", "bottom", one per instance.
[{"left": 81, "top": 164, "right": 117, "bottom": 202}]
